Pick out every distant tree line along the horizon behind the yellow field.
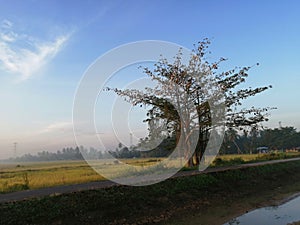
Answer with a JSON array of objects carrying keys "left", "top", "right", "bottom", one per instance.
[{"left": 1, "top": 127, "right": 300, "bottom": 162}]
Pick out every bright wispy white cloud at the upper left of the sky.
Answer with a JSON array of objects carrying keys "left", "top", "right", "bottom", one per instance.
[{"left": 0, "top": 20, "right": 70, "bottom": 80}]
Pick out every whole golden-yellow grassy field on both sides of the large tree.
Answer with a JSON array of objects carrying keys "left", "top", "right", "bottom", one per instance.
[{"left": 0, "top": 153, "right": 299, "bottom": 193}]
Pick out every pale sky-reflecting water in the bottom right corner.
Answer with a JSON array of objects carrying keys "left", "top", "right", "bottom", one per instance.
[{"left": 224, "top": 196, "right": 300, "bottom": 225}]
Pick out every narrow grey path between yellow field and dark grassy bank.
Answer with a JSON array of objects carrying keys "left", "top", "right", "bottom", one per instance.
[{"left": 0, "top": 158, "right": 300, "bottom": 203}]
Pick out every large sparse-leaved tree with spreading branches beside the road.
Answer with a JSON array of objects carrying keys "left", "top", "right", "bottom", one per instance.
[{"left": 107, "top": 39, "right": 271, "bottom": 166}]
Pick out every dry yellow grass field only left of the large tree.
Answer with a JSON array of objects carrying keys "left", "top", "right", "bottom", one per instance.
[{"left": 0, "top": 159, "right": 160, "bottom": 192}]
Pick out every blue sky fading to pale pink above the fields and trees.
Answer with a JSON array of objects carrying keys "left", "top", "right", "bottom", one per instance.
[{"left": 0, "top": 0, "right": 300, "bottom": 158}]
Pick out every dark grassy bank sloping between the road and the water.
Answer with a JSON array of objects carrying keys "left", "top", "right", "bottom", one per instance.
[{"left": 0, "top": 161, "right": 300, "bottom": 225}]
